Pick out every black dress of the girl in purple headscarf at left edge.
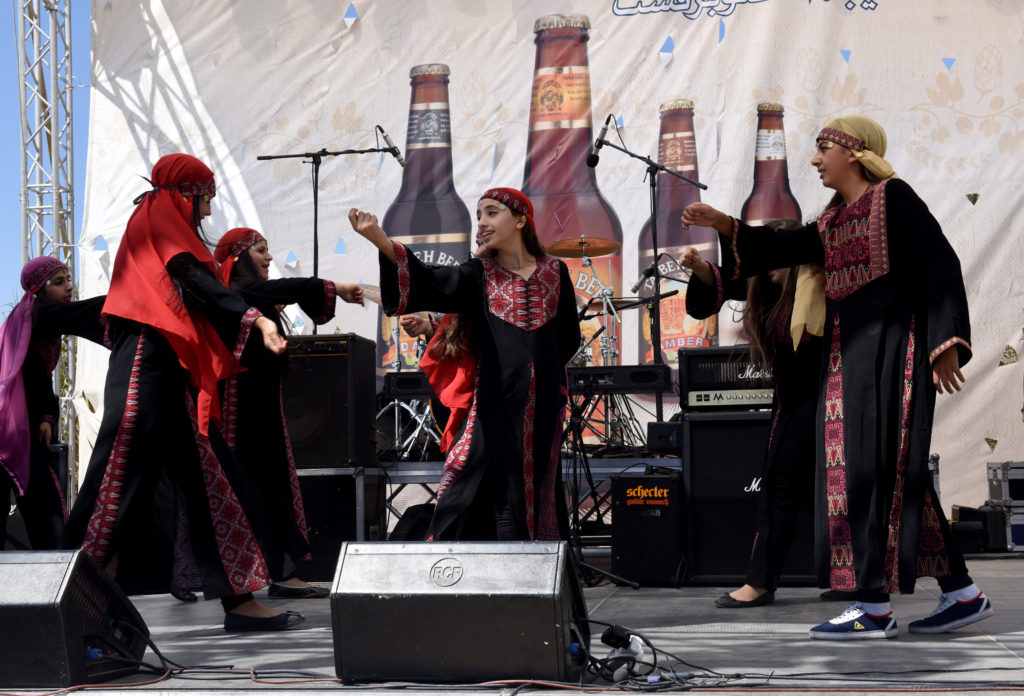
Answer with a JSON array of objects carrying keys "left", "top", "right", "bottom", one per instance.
[{"left": 0, "top": 296, "right": 106, "bottom": 551}]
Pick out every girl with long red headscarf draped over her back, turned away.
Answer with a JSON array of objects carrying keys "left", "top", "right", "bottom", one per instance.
[{"left": 67, "top": 155, "right": 302, "bottom": 632}]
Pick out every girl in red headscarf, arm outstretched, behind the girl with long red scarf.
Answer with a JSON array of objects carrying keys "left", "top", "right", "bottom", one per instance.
[{"left": 214, "top": 227, "right": 362, "bottom": 599}]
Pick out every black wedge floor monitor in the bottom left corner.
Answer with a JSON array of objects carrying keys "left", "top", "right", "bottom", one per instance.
[{"left": 0, "top": 551, "right": 150, "bottom": 689}]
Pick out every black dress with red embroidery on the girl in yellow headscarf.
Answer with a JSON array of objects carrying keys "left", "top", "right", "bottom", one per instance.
[{"left": 733, "top": 179, "right": 971, "bottom": 594}]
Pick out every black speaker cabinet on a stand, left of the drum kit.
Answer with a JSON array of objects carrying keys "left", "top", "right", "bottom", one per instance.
[{"left": 284, "top": 334, "right": 377, "bottom": 468}]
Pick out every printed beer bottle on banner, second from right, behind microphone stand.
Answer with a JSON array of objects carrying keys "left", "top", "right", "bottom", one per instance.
[{"left": 637, "top": 99, "right": 718, "bottom": 367}]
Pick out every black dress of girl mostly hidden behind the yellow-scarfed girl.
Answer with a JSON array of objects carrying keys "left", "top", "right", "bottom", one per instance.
[{"left": 686, "top": 264, "right": 821, "bottom": 590}]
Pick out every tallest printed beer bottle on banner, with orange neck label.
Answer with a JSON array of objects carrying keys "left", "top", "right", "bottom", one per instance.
[{"left": 522, "top": 14, "right": 623, "bottom": 364}]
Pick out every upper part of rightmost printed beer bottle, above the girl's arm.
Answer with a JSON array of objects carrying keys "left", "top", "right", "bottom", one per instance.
[{"left": 739, "top": 103, "right": 800, "bottom": 225}]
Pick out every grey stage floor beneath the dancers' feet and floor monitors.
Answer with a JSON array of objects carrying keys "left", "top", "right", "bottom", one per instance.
[{"left": 8, "top": 554, "right": 1024, "bottom": 696}]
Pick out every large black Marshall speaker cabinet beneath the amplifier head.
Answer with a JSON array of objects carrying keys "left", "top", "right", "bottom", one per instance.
[{"left": 683, "top": 410, "right": 817, "bottom": 585}]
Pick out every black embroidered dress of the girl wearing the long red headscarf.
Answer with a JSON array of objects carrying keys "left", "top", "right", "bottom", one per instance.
[{"left": 65, "top": 253, "right": 270, "bottom": 597}]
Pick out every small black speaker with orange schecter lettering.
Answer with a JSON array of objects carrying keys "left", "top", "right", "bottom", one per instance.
[{"left": 611, "top": 472, "right": 683, "bottom": 586}]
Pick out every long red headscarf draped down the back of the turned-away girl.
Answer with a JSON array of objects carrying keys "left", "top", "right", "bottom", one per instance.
[{"left": 103, "top": 155, "right": 242, "bottom": 435}]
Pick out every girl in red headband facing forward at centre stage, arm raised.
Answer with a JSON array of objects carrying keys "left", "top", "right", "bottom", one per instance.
[{"left": 349, "top": 188, "right": 580, "bottom": 540}]
